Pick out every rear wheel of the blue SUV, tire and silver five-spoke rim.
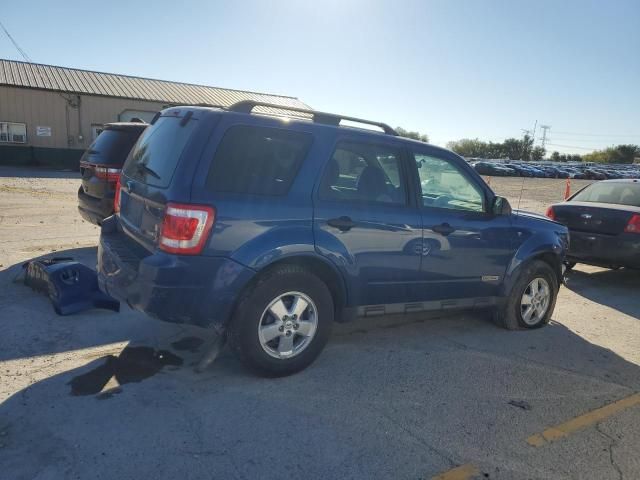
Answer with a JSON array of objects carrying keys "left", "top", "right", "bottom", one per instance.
[{"left": 227, "top": 265, "right": 334, "bottom": 377}]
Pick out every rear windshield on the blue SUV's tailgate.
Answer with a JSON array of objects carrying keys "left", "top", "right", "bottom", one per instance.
[{"left": 124, "top": 116, "right": 198, "bottom": 188}]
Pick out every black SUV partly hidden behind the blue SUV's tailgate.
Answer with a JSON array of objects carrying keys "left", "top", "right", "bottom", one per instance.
[{"left": 78, "top": 122, "right": 147, "bottom": 225}]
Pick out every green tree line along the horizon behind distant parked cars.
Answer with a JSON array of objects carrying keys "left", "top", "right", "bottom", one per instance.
[{"left": 396, "top": 127, "right": 640, "bottom": 163}]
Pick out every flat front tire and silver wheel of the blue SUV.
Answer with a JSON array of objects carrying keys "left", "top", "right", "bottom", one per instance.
[{"left": 494, "top": 260, "right": 559, "bottom": 330}]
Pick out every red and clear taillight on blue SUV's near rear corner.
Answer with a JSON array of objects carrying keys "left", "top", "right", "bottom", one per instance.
[{"left": 159, "top": 203, "right": 215, "bottom": 255}]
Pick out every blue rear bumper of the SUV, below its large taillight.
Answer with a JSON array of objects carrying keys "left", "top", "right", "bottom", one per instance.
[{"left": 98, "top": 217, "right": 255, "bottom": 330}]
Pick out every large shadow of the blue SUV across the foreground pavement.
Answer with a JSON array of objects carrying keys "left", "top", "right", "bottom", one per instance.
[{"left": 0, "top": 315, "right": 640, "bottom": 480}]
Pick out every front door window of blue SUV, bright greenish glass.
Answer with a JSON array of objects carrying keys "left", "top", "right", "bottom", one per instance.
[{"left": 414, "top": 153, "right": 484, "bottom": 212}]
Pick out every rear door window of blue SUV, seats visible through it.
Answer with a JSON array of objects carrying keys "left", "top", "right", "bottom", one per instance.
[{"left": 320, "top": 142, "right": 406, "bottom": 205}]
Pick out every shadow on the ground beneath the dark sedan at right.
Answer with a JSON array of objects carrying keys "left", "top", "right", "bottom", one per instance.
[{"left": 567, "top": 268, "right": 640, "bottom": 320}]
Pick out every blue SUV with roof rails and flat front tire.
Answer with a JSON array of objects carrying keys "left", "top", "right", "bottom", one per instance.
[{"left": 98, "top": 101, "right": 568, "bottom": 376}]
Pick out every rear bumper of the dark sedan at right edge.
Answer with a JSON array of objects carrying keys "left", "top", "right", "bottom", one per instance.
[{"left": 566, "top": 230, "right": 640, "bottom": 268}]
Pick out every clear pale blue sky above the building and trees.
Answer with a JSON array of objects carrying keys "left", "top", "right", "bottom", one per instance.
[{"left": 0, "top": 0, "right": 640, "bottom": 153}]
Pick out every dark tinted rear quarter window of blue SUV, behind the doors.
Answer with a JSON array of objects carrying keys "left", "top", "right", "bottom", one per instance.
[{"left": 206, "top": 126, "right": 312, "bottom": 195}]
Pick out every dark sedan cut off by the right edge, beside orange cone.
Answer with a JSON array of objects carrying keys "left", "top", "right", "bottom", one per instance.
[{"left": 547, "top": 180, "right": 640, "bottom": 268}]
